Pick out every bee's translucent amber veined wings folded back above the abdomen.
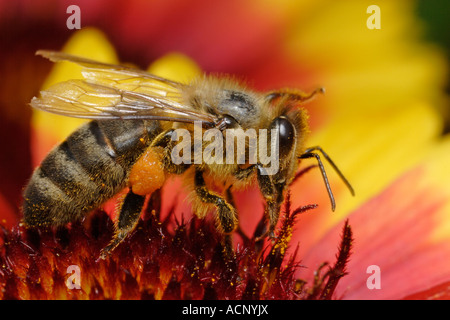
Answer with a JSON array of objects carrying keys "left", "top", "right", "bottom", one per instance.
[{"left": 31, "top": 51, "right": 217, "bottom": 125}]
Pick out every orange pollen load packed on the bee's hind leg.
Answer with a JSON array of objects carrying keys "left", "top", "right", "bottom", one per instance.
[{"left": 129, "top": 147, "right": 166, "bottom": 196}]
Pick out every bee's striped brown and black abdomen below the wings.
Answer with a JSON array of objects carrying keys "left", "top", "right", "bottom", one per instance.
[{"left": 23, "top": 120, "right": 161, "bottom": 226}]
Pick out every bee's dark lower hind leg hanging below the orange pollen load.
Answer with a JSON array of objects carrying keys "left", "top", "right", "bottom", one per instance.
[{"left": 100, "top": 189, "right": 145, "bottom": 259}]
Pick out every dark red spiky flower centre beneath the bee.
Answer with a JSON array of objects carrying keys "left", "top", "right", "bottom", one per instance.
[{"left": 0, "top": 188, "right": 352, "bottom": 300}]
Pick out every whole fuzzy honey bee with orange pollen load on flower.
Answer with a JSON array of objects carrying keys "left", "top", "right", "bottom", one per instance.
[{"left": 23, "top": 50, "right": 354, "bottom": 258}]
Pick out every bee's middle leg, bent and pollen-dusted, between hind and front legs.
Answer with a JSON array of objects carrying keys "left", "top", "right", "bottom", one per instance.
[{"left": 195, "top": 169, "right": 238, "bottom": 257}]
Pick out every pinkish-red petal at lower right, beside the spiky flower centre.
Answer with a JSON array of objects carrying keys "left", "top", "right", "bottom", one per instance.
[{"left": 300, "top": 168, "right": 450, "bottom": 299}]
